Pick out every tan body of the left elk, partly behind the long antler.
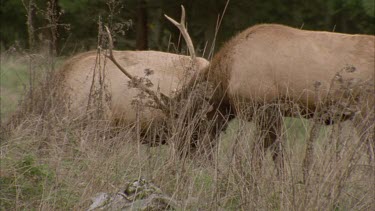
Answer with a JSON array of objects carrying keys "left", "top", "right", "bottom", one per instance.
[{"left": 61, "top": 51, "right": 208, "bottom": 137}]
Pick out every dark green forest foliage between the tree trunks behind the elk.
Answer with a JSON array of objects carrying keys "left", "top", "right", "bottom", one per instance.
[{"left": 0, "top": 0, "right": 375, "bottom": 54}]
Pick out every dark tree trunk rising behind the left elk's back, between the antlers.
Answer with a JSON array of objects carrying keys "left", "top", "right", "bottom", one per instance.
[{"left": 136, "top": 0, "right": 148, "bottom": 50}]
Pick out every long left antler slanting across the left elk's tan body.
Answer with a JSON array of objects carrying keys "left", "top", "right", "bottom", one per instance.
[{"left": 105, "top": 26, "right": 169, "bottom": 115}]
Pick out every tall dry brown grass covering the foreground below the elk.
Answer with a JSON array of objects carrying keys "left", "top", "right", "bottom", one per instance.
[{"left": 0, "top": 50, "right": 375, "bottom": 210}]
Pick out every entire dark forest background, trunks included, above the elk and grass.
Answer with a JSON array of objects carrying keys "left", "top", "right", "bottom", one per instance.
[{"left": 0, "top": 0, "right": 375, "bottom": 57}]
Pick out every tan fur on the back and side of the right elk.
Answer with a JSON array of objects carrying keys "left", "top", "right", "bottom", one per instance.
[{"left": 208, "top": 24, "right": 375, "bottom": 115}]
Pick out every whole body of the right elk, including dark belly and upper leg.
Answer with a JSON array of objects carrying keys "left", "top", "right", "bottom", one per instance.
[{"left": 198, "top": 24, "right": 375, "bottom": 165}]
